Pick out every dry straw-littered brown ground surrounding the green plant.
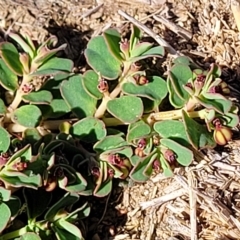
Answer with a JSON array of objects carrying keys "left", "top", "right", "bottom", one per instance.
[{"left": 0, "top": 0, "right": 240, "bottom": 240}]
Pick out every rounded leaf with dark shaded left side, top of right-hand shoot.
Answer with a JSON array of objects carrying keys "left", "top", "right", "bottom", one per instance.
[{"left": 169, "top": 64, "right": 192, "bottom": 101}]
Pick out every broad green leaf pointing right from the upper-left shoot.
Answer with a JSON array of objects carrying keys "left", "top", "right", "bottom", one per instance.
[{"left": 31, "top": 57, "right": 73, "bottom": 76}]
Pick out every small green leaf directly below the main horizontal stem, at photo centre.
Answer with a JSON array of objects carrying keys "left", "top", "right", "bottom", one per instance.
[{"left": 127, "top": 121, "right": 151, "bottom": 143}]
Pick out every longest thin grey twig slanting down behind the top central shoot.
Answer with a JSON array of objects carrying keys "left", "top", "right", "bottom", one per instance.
[{"left": 118, "top": 10, "right": 180, "bottom": 58}]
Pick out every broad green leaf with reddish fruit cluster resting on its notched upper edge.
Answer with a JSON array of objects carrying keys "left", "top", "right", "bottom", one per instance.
[{"left": 122, "top": 76, "right": 168, "bottom": 101}]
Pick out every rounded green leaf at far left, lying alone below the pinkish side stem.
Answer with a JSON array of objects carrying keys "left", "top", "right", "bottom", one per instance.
[{"left": 12, "top": 105, "right": 42, "bottom": 128}]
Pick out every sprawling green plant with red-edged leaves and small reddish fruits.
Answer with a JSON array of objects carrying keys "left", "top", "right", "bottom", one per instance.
[{"left": 0, "top": 26, "right": 239, "bottom": 240}]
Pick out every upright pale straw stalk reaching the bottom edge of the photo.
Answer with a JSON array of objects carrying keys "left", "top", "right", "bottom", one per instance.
[{"left": 188, "top": 171, "right": 198, "bottom": 240}]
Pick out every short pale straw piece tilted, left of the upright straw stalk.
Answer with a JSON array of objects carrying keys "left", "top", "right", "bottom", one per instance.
[{"left": 140, "top": 188, "right": 186, "bottom": 210}]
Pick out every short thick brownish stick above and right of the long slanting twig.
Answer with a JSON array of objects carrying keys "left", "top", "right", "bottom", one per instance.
[{"left": 153, "top": 15, "right": 192, "bottom": 40}]
